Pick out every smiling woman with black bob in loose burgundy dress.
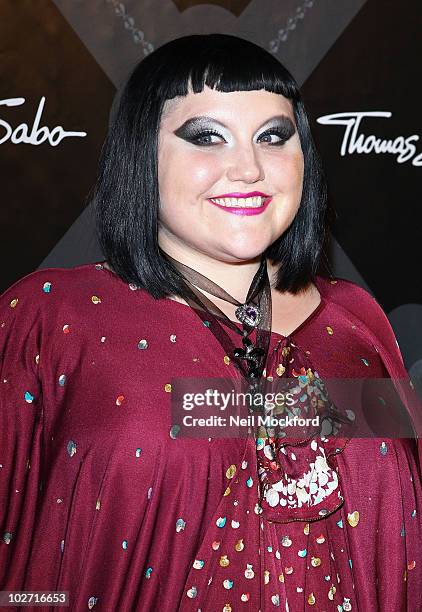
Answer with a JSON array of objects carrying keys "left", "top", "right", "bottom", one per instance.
[{"left": 0, "top": 34, "right": 422, "bottom": 612}]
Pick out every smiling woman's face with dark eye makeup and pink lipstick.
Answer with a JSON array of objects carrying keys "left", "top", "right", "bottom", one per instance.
[{"left": 158, "top": 87, "right": 303, "bottom": 263}]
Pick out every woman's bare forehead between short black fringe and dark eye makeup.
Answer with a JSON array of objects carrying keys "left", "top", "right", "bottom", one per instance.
[{"left": 161, "top": 86, "right": 294, "bottom": 124}]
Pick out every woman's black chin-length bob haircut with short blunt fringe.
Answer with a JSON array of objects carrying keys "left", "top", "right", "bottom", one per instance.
[{"left": 93, "top": 33, "right": 329, "bottom": 299}]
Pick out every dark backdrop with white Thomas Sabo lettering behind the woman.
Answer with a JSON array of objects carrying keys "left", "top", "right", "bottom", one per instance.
[{"left": 0, "top": 0, "right": 422, "bottom": 390}]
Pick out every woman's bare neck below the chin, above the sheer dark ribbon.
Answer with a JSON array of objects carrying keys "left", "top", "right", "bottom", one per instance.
[{"left": 163, "top": 244, "right": 277, "bottom": 302}]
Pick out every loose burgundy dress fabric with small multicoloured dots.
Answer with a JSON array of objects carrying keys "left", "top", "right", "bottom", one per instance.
[{"left": 0, "top": 262, "right": 422, "bottom": 612}]
